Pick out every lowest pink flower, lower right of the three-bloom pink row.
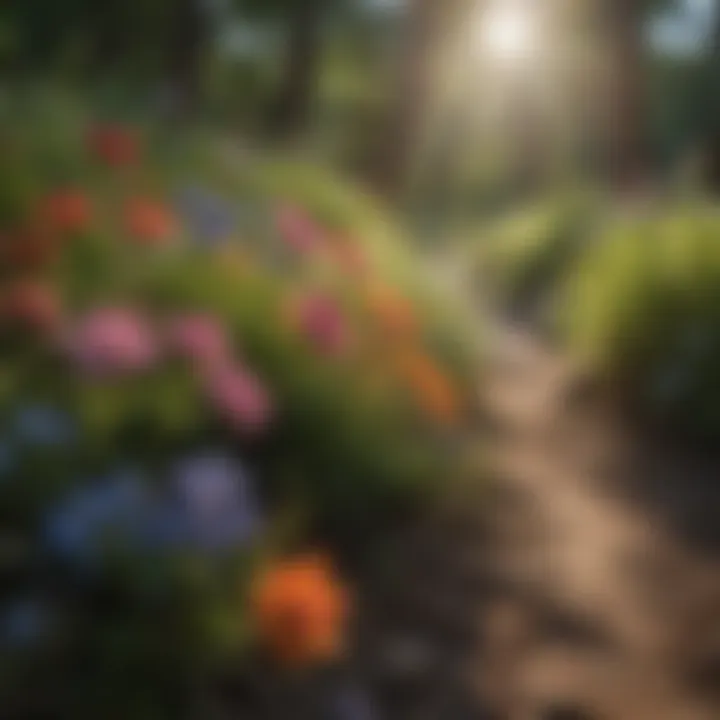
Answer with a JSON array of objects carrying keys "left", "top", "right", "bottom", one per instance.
[{"left": 207, "top": 365, "right": 273, "bottom": 434}]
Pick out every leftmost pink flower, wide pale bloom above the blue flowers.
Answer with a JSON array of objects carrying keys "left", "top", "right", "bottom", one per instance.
[{"left": 68, "top": 308, "right": 158, "bottom": 374}]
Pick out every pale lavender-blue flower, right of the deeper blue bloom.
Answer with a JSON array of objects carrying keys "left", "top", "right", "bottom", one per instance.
[{"left": 156, "top": 454, "right": 260, "bottom": 552}]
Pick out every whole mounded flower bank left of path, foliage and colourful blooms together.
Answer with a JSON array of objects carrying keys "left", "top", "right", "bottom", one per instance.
[{"left": 0, "top": 90, "right": 484, "bottom": 718}]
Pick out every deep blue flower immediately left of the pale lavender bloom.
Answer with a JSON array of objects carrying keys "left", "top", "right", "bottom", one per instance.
[{"left": 45, "top": 471, "right": 150, "bottom": 562}]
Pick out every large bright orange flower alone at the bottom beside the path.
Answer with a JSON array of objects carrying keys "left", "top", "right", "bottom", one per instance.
[{"left": 251, "top": 555, "right": 348, "bottom": 667}]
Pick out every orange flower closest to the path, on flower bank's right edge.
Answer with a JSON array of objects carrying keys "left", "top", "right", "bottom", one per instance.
[{"left": 396, "top": 351, "right": 461, "bottom": 425}]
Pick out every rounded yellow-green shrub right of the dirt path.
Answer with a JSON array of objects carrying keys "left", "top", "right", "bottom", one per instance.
[{"left": 564, "top": 207, "right": 720, "bottom": 437}]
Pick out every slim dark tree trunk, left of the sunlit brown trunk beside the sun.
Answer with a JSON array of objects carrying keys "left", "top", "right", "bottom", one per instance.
[{"left": 270, "top": 0, "right": 324, "bottom": 138}]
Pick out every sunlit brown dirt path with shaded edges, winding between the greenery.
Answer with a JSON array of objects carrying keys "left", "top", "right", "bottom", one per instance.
[{"left": 361, "top": 327, "right": 720, "bottom": 720}]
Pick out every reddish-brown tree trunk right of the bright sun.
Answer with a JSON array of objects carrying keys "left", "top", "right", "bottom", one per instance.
[{"left": 607, "top": 0, "right": 647, "bottom": 190}]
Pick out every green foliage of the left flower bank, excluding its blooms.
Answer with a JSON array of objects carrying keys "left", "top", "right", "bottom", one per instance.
[{"left": 0, "top": 88, "right": 476, "bottom": 718}]
